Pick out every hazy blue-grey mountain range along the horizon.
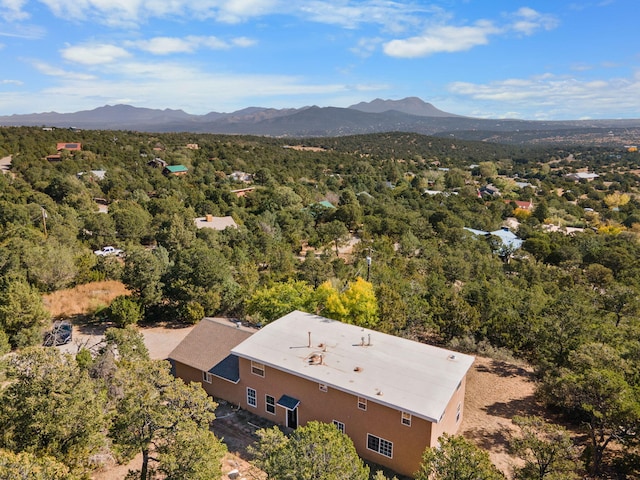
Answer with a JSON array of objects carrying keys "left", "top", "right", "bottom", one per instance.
[{"left": 0, "top": 97, "right": 640, "bottom": 144}]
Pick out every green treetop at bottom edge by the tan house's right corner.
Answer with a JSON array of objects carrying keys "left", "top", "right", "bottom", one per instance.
[{"left": 415, "top": 433, "right": 504, "bottom": 480}]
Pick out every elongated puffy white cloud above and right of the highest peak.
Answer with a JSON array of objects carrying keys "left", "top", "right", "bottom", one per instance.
[{"left": 384, "top": 21, "right": 501, "bottom": 58}]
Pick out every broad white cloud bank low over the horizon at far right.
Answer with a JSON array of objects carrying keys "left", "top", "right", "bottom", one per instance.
[{"left": 448, "top": 73, "right": 640, "bottom": 118}]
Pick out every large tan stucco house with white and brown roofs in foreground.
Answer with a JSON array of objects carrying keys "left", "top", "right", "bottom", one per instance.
[{"left": 169, "top": 311, "right": 474, "bottom": 476}]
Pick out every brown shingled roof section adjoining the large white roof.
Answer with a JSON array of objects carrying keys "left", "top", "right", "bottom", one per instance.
[{"left": 169, "top": 318, "right": 255, "bottom": 371}]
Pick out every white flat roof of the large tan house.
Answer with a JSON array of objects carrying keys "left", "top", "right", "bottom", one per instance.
[{"left": 231, "top": 310, "right": 474, "bottom": 423}]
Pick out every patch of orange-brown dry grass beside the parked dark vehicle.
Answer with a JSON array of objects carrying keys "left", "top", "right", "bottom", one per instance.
[{"left": 43, "top": 280, "right": 129, "bottom": 318}]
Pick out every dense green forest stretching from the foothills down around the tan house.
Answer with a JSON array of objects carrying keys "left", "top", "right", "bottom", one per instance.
[{"left": 0, "top": 127, "right": 640, "bottom": 479}]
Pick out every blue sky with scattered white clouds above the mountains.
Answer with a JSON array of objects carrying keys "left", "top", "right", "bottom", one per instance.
[{"left": 0, "top": 0, "right": 640, "bottom": 120}]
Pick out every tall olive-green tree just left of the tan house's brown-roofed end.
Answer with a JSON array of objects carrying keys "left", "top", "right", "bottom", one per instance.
[{"left": 110, "top": 360, "right": 224, "bottom": 480}]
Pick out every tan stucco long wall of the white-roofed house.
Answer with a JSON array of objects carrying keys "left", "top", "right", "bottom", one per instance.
[{"left": 238, "top": 358, "right": 438, "bottom": 476}]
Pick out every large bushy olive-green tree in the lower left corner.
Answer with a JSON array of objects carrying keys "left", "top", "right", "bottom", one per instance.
[{"left": 0, "top": 347, "right": 106, "bottom": 471}]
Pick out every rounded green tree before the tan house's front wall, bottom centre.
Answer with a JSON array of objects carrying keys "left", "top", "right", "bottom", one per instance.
[{"left": 251, "top": 421, "right": 369, "bottom": 480}]
